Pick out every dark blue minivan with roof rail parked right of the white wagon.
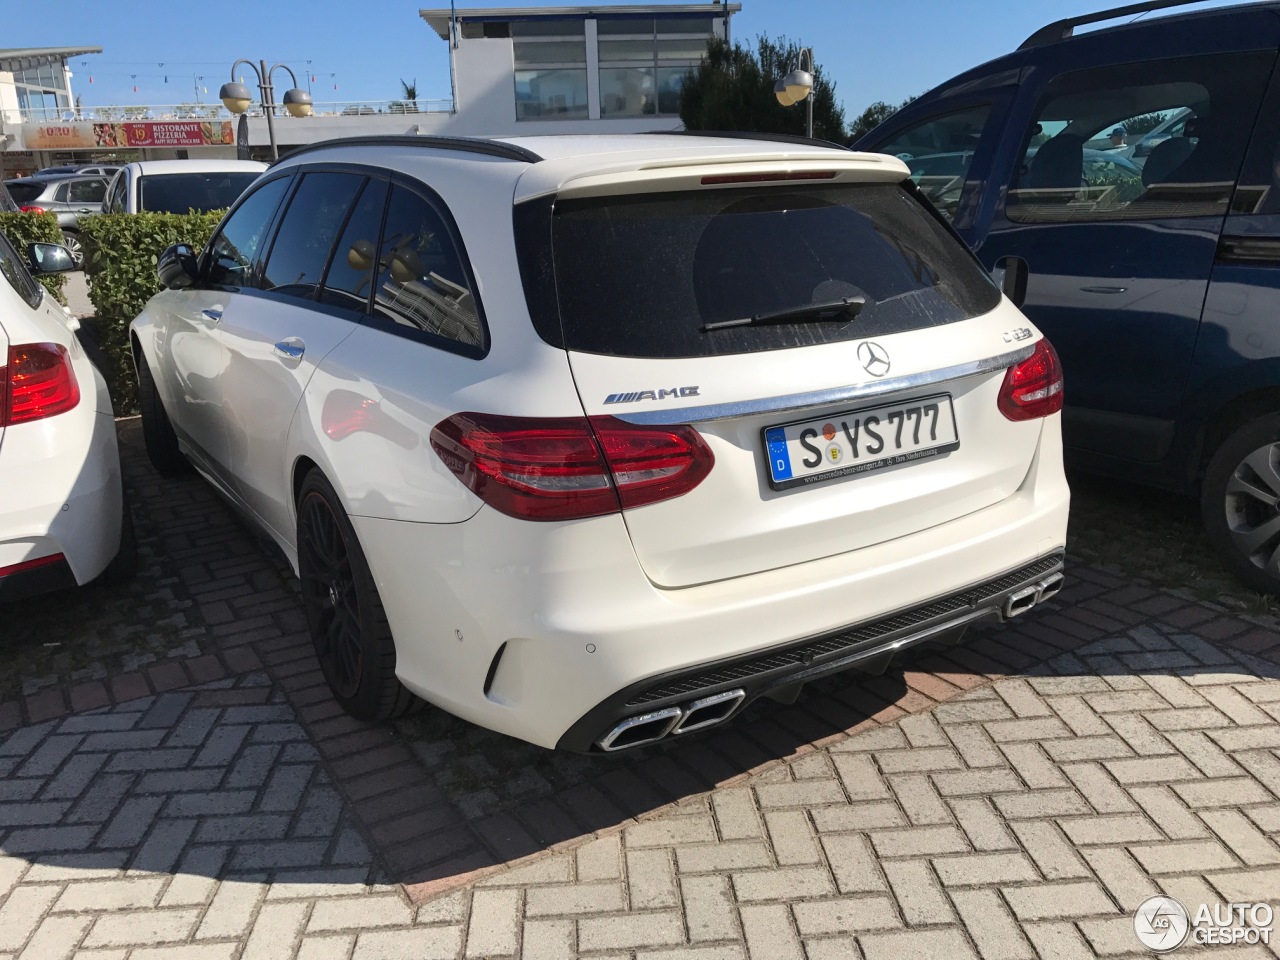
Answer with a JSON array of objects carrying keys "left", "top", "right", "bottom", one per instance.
[{"left": 854, "top": 0, "right": 1280, "bottom": 593}]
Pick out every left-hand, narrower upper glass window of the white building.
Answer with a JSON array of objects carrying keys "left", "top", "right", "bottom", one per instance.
[{"left": 511, "top": 19, "right": 588, "bottom": 120}]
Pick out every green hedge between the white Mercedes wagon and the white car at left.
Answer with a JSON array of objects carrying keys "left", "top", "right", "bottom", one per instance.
[{"left": 81, "top": 210, "right": 223, "bottom": 415}]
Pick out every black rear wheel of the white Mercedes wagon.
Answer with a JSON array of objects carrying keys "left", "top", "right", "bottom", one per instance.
[{"left": 298, "top": 470, "right": 421, "bottom": 721}]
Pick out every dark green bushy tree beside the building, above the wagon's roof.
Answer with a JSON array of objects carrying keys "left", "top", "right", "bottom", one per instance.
[{"left": 680, "top": 36, "right": 845, "bottom": 143}]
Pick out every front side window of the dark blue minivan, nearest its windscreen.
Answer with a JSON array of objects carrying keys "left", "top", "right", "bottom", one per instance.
[{"left": 876, "top": 106, "right": 991, "bottom": 220}]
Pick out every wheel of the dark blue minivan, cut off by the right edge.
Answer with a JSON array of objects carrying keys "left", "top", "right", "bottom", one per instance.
[{"left": 1201, "top": 415, "right": 1280, "bottom": 594}]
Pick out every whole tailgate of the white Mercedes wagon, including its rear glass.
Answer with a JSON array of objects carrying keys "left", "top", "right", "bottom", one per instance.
[{"left": 525, "top": 175, "right": 1041, "bottom": 586}]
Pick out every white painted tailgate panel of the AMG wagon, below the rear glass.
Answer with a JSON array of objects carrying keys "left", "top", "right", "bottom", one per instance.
[{"left": 570, "top": 320, "right": 1041, "bottom": 586}]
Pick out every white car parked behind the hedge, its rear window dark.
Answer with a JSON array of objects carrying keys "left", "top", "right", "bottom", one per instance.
[{"left": 102, "top": 160, "right": 266, "bottom": 214}]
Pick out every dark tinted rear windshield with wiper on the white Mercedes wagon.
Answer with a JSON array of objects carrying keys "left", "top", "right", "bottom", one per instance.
[{"left": 517, "top": 184, "right": 1000, "bottom": 357}]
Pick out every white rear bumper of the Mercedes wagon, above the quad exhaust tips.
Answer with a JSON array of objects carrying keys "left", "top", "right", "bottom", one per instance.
[{"left": 352, "top": 417, "right": 1070, "bottom": 749}]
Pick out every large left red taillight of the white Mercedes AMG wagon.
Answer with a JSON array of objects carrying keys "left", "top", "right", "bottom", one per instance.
[{"left": 431, "top": 413, "right": 716, "bottom": 520}]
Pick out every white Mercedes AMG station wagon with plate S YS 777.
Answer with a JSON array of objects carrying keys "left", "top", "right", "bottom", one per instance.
[{"left": 132, "top": 134, "right": 1069, "bottom": 751}]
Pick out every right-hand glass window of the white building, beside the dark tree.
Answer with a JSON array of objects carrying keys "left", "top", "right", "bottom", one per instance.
[{"left": 596, "top": 17, "right": 714, "bottom": 116}]
